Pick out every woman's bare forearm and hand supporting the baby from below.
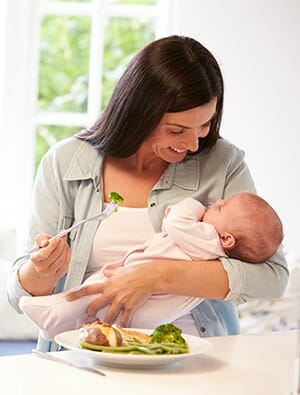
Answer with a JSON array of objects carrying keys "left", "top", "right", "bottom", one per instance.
[{"left": 68, "top": 260, "right": 229, "bottom": 326}]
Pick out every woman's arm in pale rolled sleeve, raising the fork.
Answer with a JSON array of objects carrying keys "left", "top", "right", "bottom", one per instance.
[{"left": 7, "top": 146, "right": 70, "bottom": 311}]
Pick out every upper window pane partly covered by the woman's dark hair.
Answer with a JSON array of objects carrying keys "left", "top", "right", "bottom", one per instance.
[{"left": 102, "top": 17, "right": 155, "bottom": 109}]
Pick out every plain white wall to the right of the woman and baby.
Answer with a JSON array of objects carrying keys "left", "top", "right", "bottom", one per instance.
[{"left": 170, "top": 0, "right": 300, "bottom": 257}]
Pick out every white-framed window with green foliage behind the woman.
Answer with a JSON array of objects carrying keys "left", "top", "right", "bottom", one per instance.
[{"left": 33, "top": 0, "right": 170, "bottom": 167}]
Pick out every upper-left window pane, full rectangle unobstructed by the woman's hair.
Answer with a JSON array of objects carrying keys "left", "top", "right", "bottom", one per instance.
[{"left": 38, "top": 16, "right": 90, "bottom": 112}]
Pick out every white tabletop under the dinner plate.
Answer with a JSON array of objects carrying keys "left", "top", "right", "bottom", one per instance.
[{"left": 0, "top": 332, "right": 296, "bottom": 395}]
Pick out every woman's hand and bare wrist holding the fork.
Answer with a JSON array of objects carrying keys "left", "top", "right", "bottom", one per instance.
[{"left": 19, "top": 234, "right": 71, "bottom": 296}]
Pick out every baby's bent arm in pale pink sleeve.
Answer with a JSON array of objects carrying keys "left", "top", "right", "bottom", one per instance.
[{"left": 163, "top": 198, "right": 225, "bottom": 259}]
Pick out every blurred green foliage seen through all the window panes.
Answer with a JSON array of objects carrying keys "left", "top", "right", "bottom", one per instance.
[{"left": 35, "top": 0, "right": 156, "bottom": 168}]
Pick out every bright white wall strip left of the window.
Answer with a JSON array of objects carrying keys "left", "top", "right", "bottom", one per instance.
[{"left": 0, "top": 0, "right": 37, "bottom": 238}]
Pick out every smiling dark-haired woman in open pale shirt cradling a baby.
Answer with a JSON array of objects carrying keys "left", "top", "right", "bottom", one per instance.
[{"left": 8, "top": 36, "right": 288, "bottom": 349}]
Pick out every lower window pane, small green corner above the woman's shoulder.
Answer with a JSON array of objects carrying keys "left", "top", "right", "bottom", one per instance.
[{"left": 35, "top": 125, "right": 84, "bottom": 169}]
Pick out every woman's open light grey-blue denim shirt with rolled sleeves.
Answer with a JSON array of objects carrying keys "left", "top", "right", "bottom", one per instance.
[{"left": 7, "top": 137, "right": 288, "bottom": 350}]
